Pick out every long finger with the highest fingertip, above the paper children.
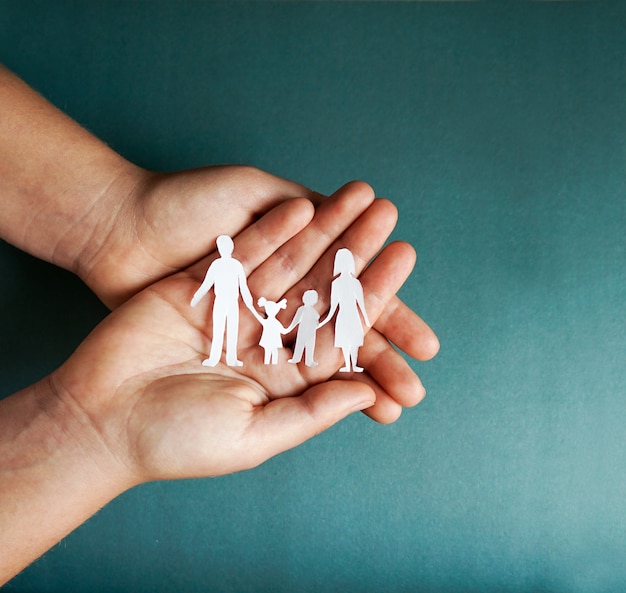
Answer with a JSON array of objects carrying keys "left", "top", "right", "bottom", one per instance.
[{"left": 250, "top": 181, "right": 376, "bottom": 300}]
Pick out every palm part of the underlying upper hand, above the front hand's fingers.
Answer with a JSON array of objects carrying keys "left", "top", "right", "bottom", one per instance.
[{"left": 79, "top": 166, "right": 322, "bottom": 308}]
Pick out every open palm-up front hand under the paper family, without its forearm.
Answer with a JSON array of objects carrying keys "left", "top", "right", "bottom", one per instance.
[{"left": 50, "top": 183, "right": 436, "bottom": 483}]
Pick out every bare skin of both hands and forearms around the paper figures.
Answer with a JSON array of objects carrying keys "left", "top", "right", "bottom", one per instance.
[{"left": 0, "top": 69, "right": 438, "bottom": 583}]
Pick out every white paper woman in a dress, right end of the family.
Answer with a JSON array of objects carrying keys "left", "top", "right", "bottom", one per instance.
[{"left": 319, "top": 248, "right": 371, "bottom": 373}]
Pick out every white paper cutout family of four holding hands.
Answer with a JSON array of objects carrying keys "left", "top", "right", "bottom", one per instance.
[{"left": 191, "top": 235, "right": 371, "bottom": 372}]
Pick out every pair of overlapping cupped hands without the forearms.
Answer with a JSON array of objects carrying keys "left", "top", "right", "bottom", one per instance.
[{"left": 47, "top": 167, "right": 438, "bottom": 486}]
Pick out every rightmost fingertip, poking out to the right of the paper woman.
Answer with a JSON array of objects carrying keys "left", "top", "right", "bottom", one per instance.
[{"left": 374, "top": 296, "right": 439, "bottom": 360}]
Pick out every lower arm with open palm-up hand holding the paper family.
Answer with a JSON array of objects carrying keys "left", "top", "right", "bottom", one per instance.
[{"left": 0, "top": 184, "right": 437, "bottom": 584}]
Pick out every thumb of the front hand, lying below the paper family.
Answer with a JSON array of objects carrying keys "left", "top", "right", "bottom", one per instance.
[{"left": 248, "top": 381, "right": 376, "bottom": 463}]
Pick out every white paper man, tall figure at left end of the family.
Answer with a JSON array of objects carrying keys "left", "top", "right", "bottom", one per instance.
[{"left": 191, "top": 235, "right": 260, "bottom": 367}]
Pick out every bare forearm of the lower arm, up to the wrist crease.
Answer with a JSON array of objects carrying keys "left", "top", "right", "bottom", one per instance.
[{"left": 0, "top": 377, "right": 133, "bottom": 584}]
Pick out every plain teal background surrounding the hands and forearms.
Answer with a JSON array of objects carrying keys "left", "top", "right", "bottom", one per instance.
[{"left": 0, "top": 0, "right": 626, "bottom": 593}]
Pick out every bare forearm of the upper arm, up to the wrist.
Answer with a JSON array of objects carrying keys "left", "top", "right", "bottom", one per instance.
[{"left": 0, "top": 66, "right": 146, "bottom": 292}]
